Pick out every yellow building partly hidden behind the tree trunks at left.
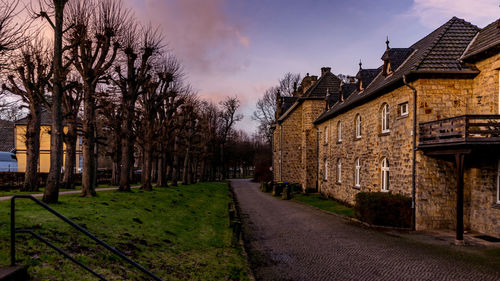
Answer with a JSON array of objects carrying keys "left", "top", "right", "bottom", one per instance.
[{"left": 14, "top": 110, "right": 83, "bottom": 173}]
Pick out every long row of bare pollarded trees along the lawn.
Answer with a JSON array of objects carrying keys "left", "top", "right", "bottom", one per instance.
[{"left": 0, "top": 0, "right": 248, "bottom": 203}]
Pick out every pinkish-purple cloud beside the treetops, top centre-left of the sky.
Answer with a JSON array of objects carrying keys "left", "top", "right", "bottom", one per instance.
[{"left": 128, "top": 0, "right": 250, "bottom": 73}]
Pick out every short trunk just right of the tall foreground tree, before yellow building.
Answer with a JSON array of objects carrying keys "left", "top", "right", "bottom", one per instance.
[{"left": 62, "top": 120, "right": 77, "bottom": 188}]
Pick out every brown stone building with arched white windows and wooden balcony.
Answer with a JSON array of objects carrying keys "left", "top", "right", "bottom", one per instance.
[{"left": 274, "top": 17, "right": 500, "bottom": 240}]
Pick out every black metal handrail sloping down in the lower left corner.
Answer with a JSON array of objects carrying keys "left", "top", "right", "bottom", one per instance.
[{"left": 10, "top": 195, "right": 163, "bottom": 281}]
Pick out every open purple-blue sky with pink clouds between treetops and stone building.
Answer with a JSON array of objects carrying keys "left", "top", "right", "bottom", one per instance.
[{"left": 125, "top": 0, "right": 500, "bottom": 134}]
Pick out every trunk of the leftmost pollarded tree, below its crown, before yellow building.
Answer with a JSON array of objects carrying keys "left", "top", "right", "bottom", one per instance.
[{"left": 21, "top": 105, "right": 40, "bottom": 191}]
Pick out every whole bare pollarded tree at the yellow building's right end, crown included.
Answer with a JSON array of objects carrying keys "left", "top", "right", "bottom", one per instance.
[{"left": 68, "top": 0, "right": 128, "bottom": 196}]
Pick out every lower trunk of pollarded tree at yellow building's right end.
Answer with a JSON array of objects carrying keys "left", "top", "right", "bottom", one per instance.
[{"left": 82, "top": 85, "right": 96, "bottom": 197}]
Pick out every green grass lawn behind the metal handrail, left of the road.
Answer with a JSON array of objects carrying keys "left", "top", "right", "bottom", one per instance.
[{"left": 0, "top": 180, "right": 248, "bottom": 280}]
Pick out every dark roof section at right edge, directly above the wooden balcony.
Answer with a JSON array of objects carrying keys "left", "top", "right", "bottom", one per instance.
[{"left": 462, "top": 19, "right": 500, "bottom": 60}]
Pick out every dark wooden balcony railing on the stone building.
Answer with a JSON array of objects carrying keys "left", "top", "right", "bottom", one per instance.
[{"left": 418, "top": 115, "right": 500, "bottom": 148}]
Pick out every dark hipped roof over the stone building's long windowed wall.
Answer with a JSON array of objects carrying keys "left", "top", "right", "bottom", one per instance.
[{"left": 314, "top": 17, "right": 479, "bottom": 123}]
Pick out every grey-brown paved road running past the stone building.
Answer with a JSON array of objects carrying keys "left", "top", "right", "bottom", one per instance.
[{"left": 232, "top": 180, "right": 500, "bottom": 281}]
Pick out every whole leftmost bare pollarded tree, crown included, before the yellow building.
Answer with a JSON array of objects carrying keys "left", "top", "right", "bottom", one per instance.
[{"left": 2, "top": 40, "right": 52, "bottom": 191}]
